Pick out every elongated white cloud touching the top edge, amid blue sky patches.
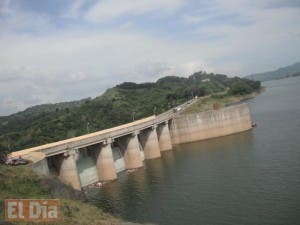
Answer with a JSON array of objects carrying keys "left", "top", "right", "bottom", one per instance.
[{"left": 86, "top": 0, "right": 185, "bottom": 22}]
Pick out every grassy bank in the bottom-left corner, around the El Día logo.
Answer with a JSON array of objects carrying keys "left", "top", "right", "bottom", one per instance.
[{"left": 0, "top": 165, "right": 141, "bottom": 225}]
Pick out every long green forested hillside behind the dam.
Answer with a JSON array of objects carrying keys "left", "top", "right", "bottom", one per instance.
[{"left": 0, "top": 72, "right": 260, "bottom": 152}]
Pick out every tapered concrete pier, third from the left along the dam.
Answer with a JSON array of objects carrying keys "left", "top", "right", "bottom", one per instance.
[{"left": 124, "top": 132, "right": 143, "bottom": 169}]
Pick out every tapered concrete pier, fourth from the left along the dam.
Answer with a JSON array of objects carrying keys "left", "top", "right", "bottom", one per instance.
[{"left": 141, "top": 126, "right": 161, "bottom": 159}]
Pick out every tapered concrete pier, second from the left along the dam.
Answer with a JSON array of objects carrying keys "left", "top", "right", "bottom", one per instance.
[{"left": 96, "top": 139, "right": 117, "bottom": 181}]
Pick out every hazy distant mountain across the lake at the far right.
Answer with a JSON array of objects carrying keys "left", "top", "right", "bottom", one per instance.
[{"left": 245, "top": 62, "right": 300, "bottom": 81}]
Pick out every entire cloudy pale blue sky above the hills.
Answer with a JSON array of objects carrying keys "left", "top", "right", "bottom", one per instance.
[{"left": 0, "top": 0, "right": 300, "bottom": 116}]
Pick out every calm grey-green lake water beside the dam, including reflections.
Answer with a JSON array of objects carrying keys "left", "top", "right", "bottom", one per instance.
[{"left": 88, "top": 77, "right": 300, "bottom": 225}]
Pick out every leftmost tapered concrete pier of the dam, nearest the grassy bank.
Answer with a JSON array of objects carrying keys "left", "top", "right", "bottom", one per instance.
[{"left": 59, "top": 150, "right": 81, "bottom": 190}]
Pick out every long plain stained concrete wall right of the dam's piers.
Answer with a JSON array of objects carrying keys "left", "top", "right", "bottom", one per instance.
[{"left": 170, "top": 104, "right": 251, "bottom": 145}]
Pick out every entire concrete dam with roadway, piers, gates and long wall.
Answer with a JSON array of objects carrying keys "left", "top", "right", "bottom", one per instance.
[{"left": 8, "top": 102, "right": 251, "bottom": 190}]
